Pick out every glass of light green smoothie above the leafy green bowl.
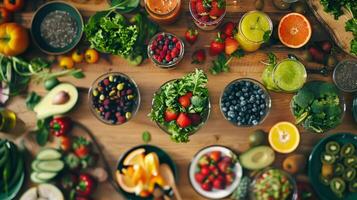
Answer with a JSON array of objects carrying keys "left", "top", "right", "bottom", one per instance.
[{"left": 272, "top": 58, "right": 307, "bottom": 92}]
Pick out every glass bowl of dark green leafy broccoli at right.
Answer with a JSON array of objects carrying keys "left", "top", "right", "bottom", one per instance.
[{"left": 291, "top": 81, "right": 346, "bottom": 133}]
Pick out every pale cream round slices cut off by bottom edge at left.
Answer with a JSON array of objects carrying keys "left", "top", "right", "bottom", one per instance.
[{"left": 20, "top": 184, "right": 64, "bottom": 200}]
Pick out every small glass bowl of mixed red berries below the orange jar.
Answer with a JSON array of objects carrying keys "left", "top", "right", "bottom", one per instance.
[{"left": 148, "top": 32, "right": 185, "bottom": 69}]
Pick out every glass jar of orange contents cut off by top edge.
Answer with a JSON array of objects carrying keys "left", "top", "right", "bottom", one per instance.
[{"left": 145, "top": 0, "right": 182, "bottom": 24}]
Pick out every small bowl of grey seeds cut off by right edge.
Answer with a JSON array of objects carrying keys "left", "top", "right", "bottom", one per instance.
[{"left": 333, "top": 60, "right": 357, "bottom": 92}]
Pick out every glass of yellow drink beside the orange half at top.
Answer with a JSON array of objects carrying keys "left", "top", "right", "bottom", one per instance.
[{"left": 235, "top": 10, "right": 273, "bottom": 52}]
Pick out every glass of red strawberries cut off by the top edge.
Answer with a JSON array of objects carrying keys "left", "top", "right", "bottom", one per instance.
[{"left": 189, "top": 0, "right": 226, "bottom": 30}]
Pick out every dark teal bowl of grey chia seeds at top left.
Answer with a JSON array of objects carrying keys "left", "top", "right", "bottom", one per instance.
[{"left": 31, "top": 1, "right": 83, "bottom": 55}]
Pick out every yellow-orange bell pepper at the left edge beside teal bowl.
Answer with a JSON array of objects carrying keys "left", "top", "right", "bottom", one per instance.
[{"left": 0, "top": 23, "right": 29, "bottom": 56}]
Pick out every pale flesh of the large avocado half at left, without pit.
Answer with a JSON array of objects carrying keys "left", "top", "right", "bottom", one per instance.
[{"left": 34, "top": 83, "right": 78, "bottom": 119}]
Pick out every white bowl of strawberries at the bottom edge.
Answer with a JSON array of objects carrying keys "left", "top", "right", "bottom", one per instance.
[{"left": 188, "top": 145, "right": 243, "bottom": 199}]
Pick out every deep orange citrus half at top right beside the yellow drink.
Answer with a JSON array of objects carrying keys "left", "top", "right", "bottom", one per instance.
[{"left": 278, "top": 13, "right": 312, "bottom": 48}]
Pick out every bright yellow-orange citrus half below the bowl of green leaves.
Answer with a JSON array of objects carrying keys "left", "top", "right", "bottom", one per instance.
[{"left": 269, "top": 122, "right": 300, "bottom": 153}]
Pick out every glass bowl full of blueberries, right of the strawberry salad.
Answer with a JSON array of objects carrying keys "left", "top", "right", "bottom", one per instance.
[{"left": 220, "top": 78, "right": 271, "bottom": 127}]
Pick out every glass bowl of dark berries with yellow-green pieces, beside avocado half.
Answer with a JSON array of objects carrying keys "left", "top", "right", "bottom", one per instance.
[{"left": 88, "top": 72, "right": 140, "bottom": 125}]
